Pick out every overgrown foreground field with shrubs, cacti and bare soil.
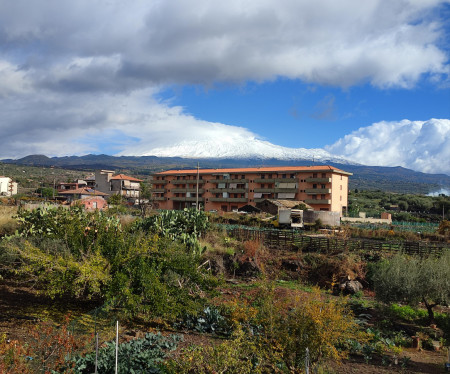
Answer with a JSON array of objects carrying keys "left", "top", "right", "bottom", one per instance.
[{"left": 0, "top": 207, "right": 450, "bottom": 373}]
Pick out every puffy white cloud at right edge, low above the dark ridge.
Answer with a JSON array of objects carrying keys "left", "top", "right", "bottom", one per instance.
[{"left": 326, "top": 119, "right": 450, "bottom": 175}]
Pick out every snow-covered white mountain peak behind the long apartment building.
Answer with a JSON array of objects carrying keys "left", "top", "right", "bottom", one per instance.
[{"left": 140, "top": 137, "right": 356, "bottom": 164}]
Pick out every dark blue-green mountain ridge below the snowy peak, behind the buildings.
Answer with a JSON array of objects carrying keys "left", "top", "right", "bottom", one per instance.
[{"left": 2, "top": 155, "right": 450, "bottom": 193}]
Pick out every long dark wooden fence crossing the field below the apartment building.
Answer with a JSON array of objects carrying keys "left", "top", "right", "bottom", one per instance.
[{"left": 227, "top": 227, "right": 450, "bottom": 256}]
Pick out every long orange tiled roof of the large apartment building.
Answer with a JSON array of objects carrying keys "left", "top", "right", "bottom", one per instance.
[{"left": 155, "top": 165, "right": 351, "bottom": 175}]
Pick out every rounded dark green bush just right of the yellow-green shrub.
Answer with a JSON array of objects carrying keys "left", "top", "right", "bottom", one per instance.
[{"left": 106, "top": 236, "right": 217, "bottom": 319}]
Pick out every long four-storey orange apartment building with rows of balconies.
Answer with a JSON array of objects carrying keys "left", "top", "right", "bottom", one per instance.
[{"left": 152, "top": 166, "right": 352, "bottom": 214}]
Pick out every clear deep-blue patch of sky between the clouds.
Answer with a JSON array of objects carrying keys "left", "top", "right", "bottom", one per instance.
[{"left": 159, "top": 77, "right": 450, "bottom": 148}]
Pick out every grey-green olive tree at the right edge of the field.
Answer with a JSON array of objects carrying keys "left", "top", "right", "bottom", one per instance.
[{"left": 373, "top": 250, "right": 450, "bottom": 323}]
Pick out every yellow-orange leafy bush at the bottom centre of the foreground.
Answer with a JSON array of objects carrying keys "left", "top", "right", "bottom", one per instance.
[{"left": 168, "top": 284, "right": 360, "bottom": 373}]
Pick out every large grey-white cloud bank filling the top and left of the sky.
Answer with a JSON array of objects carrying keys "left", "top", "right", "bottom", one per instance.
[{"left": 0, "top": 0, "right": 449, "bottom": 175}]
